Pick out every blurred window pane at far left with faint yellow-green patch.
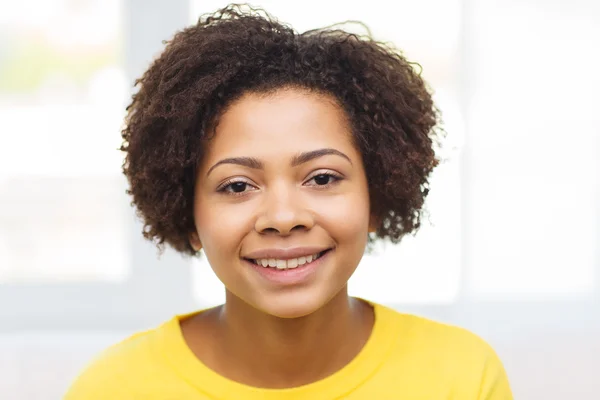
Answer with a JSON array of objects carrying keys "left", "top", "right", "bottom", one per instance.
[{"left": 0, "top": 0, "right": 130, "bottom": 282}]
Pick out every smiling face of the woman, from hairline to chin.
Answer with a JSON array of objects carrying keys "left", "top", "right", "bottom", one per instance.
[{"left": 190, "top": 89, "right": 370, "bottom": 318}]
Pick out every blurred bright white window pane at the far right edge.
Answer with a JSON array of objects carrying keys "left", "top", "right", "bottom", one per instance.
[{"left": 468, "top": 0, "right": 600, "bottom": 298}]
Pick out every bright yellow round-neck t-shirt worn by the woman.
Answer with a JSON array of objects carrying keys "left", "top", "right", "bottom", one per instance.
[{"left": 65, "top": 304, "right": 513, "bottom": 400}]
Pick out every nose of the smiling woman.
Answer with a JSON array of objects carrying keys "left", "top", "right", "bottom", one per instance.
[{"left": 255, "top": 185, "right": 314, "bottom": 236}]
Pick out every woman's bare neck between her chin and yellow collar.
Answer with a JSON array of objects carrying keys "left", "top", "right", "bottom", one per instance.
[{"left": 192, "top": 289, "right": 373, "bottom": 388}]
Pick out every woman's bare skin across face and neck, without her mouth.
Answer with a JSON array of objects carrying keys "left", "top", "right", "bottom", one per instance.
[{"left": 182, "top": 88, "right": 374, "bottom": 388}]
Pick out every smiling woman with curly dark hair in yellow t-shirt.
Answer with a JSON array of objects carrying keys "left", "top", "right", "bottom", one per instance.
[{"left": 66, "top": 6, "right": 512, "bottom": 400}]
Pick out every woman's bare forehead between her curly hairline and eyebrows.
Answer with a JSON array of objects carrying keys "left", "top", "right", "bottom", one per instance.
[{"left": 206, "top": 89, "right": 354, "bottom": 159}]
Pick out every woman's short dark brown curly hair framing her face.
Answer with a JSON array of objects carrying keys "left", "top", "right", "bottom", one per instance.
[{"left": 121, "top": 5, "right": 442, "bottom": 255}]
